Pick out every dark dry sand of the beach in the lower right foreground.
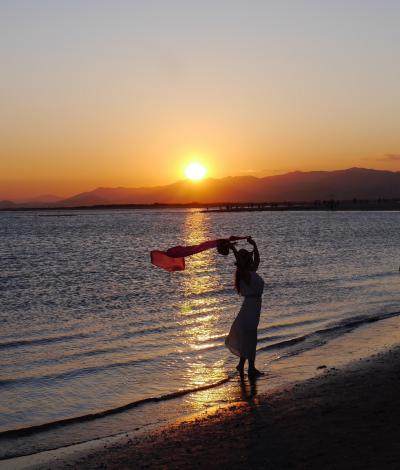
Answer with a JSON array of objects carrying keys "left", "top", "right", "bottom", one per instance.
[{"left": 32, "top": 348, "right": 400, "bottom": 469}]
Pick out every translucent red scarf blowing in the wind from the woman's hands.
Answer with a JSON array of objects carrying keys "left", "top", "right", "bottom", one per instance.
[{"left": 150, "top": 235, "right": 248, "bottom": 272}]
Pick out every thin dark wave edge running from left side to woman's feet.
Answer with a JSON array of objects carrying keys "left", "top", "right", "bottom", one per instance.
[{"left": 0, "top": 372, "right": 237, "bottom": 438}]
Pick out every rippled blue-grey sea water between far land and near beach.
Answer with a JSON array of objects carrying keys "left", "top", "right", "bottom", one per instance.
[{"left": 0, "top": 210, "right": 400, "bottom": 456}]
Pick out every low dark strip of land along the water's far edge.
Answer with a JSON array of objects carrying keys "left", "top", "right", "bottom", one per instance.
[{"left": 0, "top": 199, "right": 400, "bottom": 212}]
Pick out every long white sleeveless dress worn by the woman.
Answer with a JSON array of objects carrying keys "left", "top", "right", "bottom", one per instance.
[{"left": 225, "top": 271, "right": 264, "bottom": 360}]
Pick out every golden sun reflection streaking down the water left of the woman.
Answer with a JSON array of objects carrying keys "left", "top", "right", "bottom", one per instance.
[{"left": 178, "top": 212, "right": 256, "bottom": 412}]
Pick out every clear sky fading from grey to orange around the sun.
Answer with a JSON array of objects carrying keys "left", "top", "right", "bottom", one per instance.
[{"left": 0, "top": 0, "right": 400, "bottom": 200}]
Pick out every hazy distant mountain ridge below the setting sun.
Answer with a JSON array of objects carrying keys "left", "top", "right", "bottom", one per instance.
[{"left": 0, "top": 168, "right": 400, "bottom": 208}]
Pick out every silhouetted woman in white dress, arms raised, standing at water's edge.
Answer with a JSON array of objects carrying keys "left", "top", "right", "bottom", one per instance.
[{"left": 225, "top": 237, "right": 264, "bottom": 377}]
